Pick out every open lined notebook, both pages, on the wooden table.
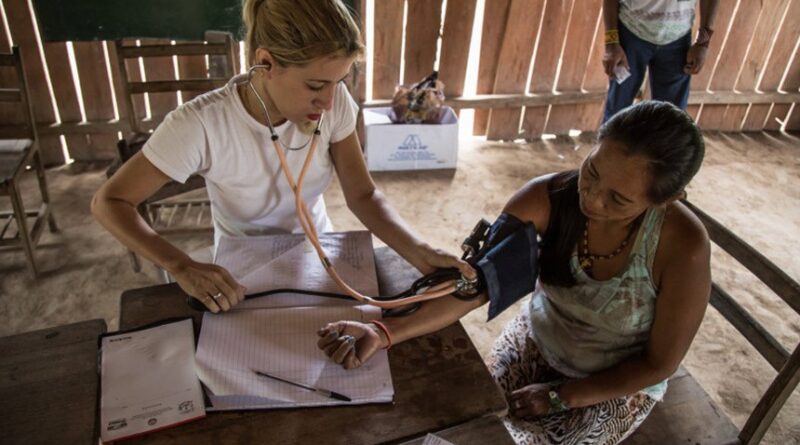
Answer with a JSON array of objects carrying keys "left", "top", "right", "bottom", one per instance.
[{"left": 195, "top": 232, "right": 394, "bottom": 410}]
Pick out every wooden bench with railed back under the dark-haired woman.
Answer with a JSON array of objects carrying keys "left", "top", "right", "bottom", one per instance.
[{"left": 625, "top": 201, "right": 800, "bottom": 445}]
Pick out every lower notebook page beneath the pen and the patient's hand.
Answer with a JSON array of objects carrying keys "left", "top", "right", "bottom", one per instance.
[{"left": 196, "top": 306, "right": 394, "bottom": 410}]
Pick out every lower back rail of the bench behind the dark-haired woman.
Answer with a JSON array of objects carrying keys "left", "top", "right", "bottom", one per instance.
[{"left": 711, "top": 283, "right": 789, "bottom": 371}]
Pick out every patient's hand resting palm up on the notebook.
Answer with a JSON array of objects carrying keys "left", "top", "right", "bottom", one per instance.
[{"left": 317, "top": 321, "right": 384, "bottom": 369}]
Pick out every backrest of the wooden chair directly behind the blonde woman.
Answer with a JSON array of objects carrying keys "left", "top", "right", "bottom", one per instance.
[{"left": 116, "top": 34, "right": 236, "bottom": 133}]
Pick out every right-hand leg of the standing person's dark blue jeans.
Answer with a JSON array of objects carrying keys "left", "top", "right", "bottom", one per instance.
[{"left": 650, "top": 33, "right": 692, "bottom": 110}]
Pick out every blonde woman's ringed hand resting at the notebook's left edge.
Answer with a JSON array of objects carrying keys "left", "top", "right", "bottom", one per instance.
[{"left": 170, "top": 260, "right": 246, "bottom": 313}]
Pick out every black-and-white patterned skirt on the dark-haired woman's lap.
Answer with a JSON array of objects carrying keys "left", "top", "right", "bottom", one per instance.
[{"left": 488, "top": 306, "right": 656, "bottom": 445}]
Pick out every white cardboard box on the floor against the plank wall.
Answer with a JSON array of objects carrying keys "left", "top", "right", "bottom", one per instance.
[{"left": 363, "top": 107, "right": 458, "bottom": 171}]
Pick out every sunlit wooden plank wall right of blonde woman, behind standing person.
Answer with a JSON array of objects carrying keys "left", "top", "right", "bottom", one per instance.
[{"left": 366, "top": 0, "right": 800, "bottom": 140}]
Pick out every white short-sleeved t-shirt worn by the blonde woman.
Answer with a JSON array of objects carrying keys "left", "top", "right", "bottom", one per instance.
[{"left": 142, "top": 75, "right": 358, "bottom": 246}]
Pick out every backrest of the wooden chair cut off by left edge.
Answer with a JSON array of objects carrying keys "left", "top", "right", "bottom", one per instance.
[{"left": 0, "top": 46, "right": 36, "bottom": 141}]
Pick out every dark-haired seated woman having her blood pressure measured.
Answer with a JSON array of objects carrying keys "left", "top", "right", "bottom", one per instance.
[{"left": 319, "top": 101, "right": 711, "bottom": 444}]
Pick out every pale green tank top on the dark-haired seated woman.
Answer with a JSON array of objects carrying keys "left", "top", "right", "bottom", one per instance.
[{"left": 529, "top": 207, "right": 667, "bottom": 400}]
